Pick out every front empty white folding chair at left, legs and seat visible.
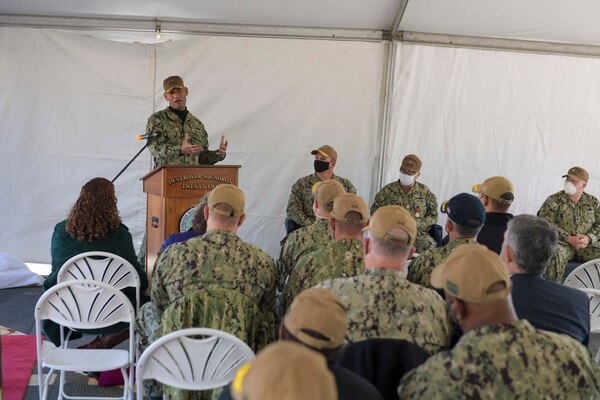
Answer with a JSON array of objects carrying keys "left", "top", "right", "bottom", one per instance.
[{"left": 35, "top": 280, "right": 135, "bottom": 400}]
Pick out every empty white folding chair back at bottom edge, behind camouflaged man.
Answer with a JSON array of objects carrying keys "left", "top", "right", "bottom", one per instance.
[{"left": 136, "top": 328, "right": 254, "bottom": 400}]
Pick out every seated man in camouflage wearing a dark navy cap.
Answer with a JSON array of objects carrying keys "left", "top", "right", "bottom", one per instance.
[{"left": 407, "top": 193, "right": 485, "bottom": 288}]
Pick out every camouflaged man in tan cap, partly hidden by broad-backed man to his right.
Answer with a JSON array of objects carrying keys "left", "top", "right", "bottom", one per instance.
[{"left": 284, "top": 193, "right": 369, "bottom": 308}]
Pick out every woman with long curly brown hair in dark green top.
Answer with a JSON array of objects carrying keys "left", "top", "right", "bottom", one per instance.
[{"left": 44, "top": 178, "right": 148, "bottom": 348}]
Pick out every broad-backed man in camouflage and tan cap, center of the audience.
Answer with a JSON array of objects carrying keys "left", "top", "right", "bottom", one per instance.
[{"left": 317, "top": 206, "right": 452, "bottom": 354}]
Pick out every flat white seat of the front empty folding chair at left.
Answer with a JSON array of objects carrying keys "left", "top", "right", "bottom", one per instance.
[{"left": 43, "top": 349, "right": 129, "bottom": 371}]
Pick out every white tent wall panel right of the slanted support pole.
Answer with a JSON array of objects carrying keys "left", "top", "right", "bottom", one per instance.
[{"left": 383, "top": 43, "right": 600, "bottom": 222}]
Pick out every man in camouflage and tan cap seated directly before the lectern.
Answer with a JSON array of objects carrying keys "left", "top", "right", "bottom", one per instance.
[{"left": 136, "top": 184, "right": 276, "bottom": 372}]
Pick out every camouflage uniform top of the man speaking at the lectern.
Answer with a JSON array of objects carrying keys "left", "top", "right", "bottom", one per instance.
[{"left": 146, "top": 107, "right": 225, "bottom": 168}]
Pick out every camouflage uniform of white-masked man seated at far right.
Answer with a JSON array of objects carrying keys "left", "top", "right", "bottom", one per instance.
[{"left": 538, "top": 191, "right": 600, "bottom": 283}]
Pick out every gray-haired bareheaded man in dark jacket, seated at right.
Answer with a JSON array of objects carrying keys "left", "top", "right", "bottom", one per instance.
[{"left": 501, "top": 215, "right": 590, "bottom": 345}]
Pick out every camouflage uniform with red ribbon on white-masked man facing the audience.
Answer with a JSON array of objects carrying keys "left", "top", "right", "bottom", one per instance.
[{"left": 371, "top": 181, "right": 438, "bottom": 253}]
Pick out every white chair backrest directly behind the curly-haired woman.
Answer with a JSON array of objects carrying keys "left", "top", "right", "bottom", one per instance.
[{"left": 56, "top": 251, "right": 140, "bottom": 309}]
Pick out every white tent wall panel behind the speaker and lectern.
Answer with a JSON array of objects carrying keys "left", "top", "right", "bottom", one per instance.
[{"left": 0, "top": 28, "right": 386, "bottom": 262}]
